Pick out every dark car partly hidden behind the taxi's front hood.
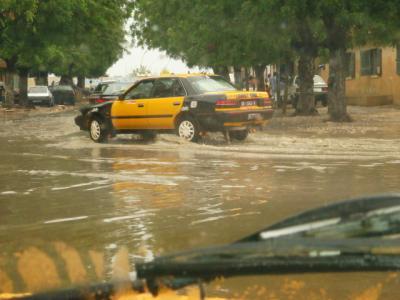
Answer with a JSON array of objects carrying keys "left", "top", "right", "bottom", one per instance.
[{"left": 89, "top": 81, "right": 133, "bottom": 104}]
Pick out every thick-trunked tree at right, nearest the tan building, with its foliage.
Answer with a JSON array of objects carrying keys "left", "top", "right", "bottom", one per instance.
[{"left": 319, "top": 0, "right": 400, "bottom": 121}]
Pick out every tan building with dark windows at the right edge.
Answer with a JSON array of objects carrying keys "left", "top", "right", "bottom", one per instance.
[{"left": 321, "top": 47, "right": 400, "bottom": 106}]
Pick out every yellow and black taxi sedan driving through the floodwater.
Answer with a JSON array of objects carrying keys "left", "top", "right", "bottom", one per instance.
[{"left": 75, "top": 74, "right": 273, "bottom": 142}]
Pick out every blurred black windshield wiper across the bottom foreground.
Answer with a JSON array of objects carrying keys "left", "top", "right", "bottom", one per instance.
[{"left": 19, "top": 195, "right": 400, "bottom": 299}]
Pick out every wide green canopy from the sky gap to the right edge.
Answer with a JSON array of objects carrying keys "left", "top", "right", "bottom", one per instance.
[{"left": 132, "top": 0, "right": 399, "bottom": 66}]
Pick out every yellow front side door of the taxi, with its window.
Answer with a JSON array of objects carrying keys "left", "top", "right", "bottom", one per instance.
[{"left": 111, "top": 80, "right": 154, "bottom": 130}]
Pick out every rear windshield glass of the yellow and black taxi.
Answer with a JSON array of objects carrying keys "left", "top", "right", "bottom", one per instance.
[{"left": 188, "top": 76, "right": 236, "bottom": 94}]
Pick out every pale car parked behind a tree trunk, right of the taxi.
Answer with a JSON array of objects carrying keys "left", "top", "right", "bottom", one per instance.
[{"left": 288, "top": 75, "right": 328, "bottom": 108}]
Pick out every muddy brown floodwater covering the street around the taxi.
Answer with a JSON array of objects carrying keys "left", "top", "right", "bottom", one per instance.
[{"left": 0, "top": 112, "right": 400, "bottom": 299}]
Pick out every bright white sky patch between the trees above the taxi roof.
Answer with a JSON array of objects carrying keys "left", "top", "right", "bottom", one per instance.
[{"left": 107, "top": 46, "right": 208, "bottom": 77}]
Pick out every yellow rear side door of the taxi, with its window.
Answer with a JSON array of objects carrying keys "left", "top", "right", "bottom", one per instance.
[{"left": 148, "top": 78, "right": 186, "bottom": 129}]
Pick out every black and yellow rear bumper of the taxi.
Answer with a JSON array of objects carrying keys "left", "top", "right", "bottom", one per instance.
[{"left": 198, "top": 109, "right": 273, "bottom": 131}]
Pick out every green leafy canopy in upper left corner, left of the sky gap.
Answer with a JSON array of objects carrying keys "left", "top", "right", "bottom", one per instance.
[{"left": 0, "top": 0, "right": 130, "bottom": 76}]
